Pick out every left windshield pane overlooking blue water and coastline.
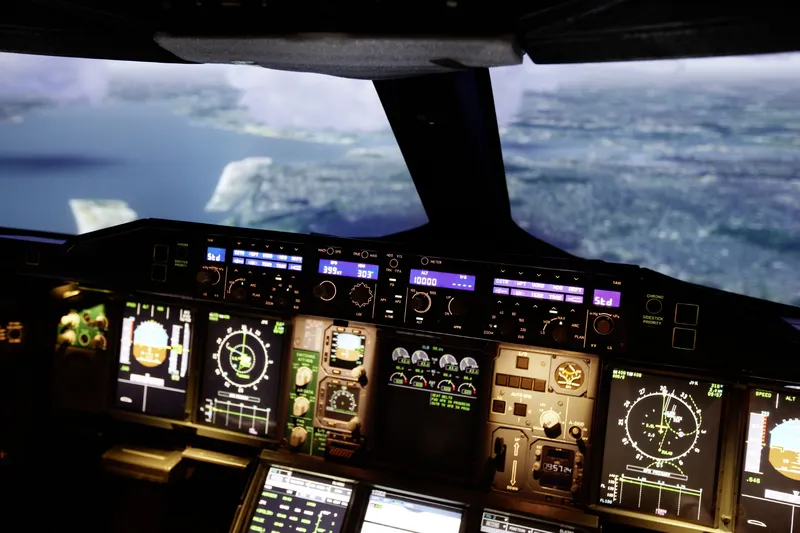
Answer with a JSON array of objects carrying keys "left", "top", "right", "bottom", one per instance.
[{"left": 0, "top": 54, "right": 427, "bottom": 237}]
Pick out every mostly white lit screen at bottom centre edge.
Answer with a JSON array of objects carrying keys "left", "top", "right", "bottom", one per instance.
[{"left": 361, "top": 489, "right": 463, "bottom": 533}]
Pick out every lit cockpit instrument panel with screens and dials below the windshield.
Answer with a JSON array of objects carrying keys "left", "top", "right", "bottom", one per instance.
[{"left": 3, "top": 218, "right": 800, "bottom": 533}]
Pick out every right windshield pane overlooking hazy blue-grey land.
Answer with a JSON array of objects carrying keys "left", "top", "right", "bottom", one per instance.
[{"left": 492, "top": 54, "right": 800, "bottom": 305}]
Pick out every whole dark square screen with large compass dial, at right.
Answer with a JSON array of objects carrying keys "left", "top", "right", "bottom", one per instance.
[{"left": 600, "top": 369, "right": 723, "bottom": 525}]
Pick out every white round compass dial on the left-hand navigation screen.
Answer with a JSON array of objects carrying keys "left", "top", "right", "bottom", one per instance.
[{"left": 213, "top": 325, "right": 272, "bottom": 392}]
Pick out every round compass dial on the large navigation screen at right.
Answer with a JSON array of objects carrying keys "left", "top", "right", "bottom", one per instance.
[{"left": 623, "top": 386, "right": 704, "bottom": 462}]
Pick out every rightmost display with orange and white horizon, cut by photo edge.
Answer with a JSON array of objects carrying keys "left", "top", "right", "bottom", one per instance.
[{"left": 736, "top": 390, "right": 800, "bottom": 533}]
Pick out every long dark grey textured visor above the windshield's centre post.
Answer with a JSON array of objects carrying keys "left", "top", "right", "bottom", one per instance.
[{"left": 155, "top": 33, "right": 522, "bottom": 79}]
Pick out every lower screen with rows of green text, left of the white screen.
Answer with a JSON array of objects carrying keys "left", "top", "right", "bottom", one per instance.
[{"left": 247, "top": 466, "right": 353, "bottom": 533}]
